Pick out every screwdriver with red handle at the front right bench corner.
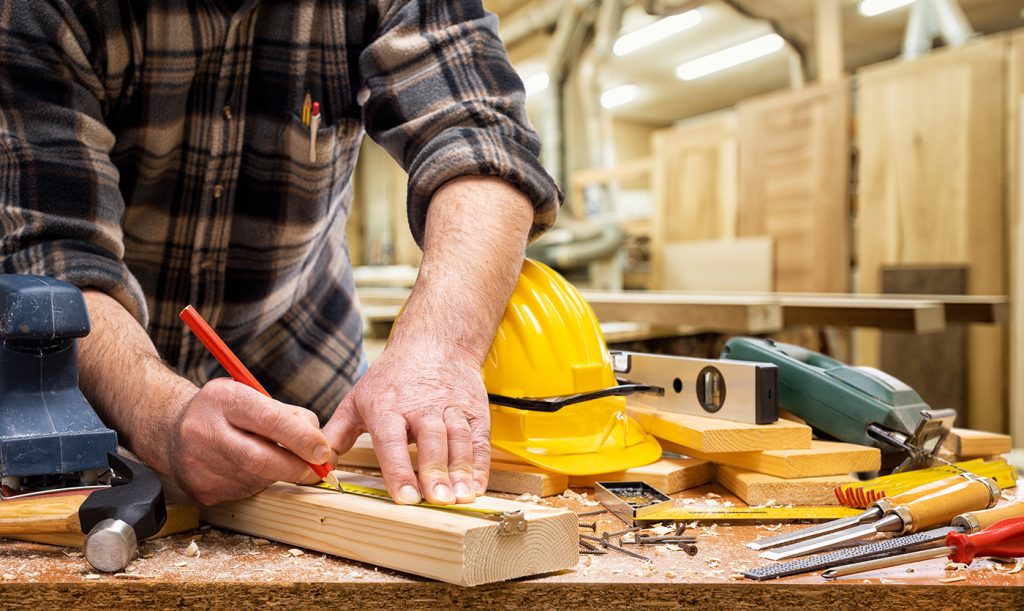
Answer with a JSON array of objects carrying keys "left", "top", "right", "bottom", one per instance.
[{"left": 821, "top": 517, "right": 1024, "bottom": 579}]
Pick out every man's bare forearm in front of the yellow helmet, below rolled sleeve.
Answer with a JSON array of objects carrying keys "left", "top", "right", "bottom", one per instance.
[{"left": 392, "top": 176, "right": 534, "bottom": 364}]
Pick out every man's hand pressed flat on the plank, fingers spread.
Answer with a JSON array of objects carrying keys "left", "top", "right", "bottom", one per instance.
[{"left": 324, "top": 342, "right": 490, "bottom": 505}]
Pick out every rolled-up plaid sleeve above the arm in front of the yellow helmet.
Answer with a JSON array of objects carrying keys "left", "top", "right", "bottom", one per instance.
[{"left": 359, "top": 0, "right": 562, "bottom": 246}]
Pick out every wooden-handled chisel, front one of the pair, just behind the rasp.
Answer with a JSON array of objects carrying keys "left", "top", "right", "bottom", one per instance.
[{"left": 761, "top": 479, "right": 1000, "bottom": 560}]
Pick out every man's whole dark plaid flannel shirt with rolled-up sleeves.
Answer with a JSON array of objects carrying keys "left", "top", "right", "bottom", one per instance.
[{"left": 0, "top": 0, "right": 561, "bottom": 418}]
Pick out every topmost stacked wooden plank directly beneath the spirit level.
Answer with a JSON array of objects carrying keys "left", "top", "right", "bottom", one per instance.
[{"left": 629, "top": 406, "right": 811, "bottom": 452}]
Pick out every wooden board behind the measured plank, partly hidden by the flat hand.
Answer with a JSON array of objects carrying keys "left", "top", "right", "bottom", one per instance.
[{"left": 338, "top": 434, "right": 569, "bottom": 496}]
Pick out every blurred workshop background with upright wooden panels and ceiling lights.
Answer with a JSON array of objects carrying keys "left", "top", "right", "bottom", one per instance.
[{"left": 348, "top": 0, "right": 1024, "bottom": 445}]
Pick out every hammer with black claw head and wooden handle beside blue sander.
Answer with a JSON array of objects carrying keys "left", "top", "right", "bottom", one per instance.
[{"left": 0, "top": 452, "right": 167, "bottom": 573}]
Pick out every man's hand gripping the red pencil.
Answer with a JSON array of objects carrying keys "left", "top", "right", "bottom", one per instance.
[{"left": 168, "top": 379, "right": 333, "bottom": 505}]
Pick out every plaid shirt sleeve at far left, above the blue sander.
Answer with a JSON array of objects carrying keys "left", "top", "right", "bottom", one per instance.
[{"left": 0, "top": 2, "right": 147, "bottom": 325}]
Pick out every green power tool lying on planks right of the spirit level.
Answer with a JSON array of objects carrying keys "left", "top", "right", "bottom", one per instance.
[{"left": 722, "top": 338, "right": 956, "bottom": 472}]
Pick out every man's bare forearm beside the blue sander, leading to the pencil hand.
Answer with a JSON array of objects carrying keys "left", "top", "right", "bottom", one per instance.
[{"left": 79, "top": 290, "right": 199, "bottom": 473}]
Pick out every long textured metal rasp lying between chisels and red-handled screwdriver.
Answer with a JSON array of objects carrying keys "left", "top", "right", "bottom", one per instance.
[{"left": 742, "top": 500, "right": 1024, "bottom": 581}]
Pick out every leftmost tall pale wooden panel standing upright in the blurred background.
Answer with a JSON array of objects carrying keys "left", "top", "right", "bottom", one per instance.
[{"left": 650, "top": 111, "right": 738, "bottom": 289}]
